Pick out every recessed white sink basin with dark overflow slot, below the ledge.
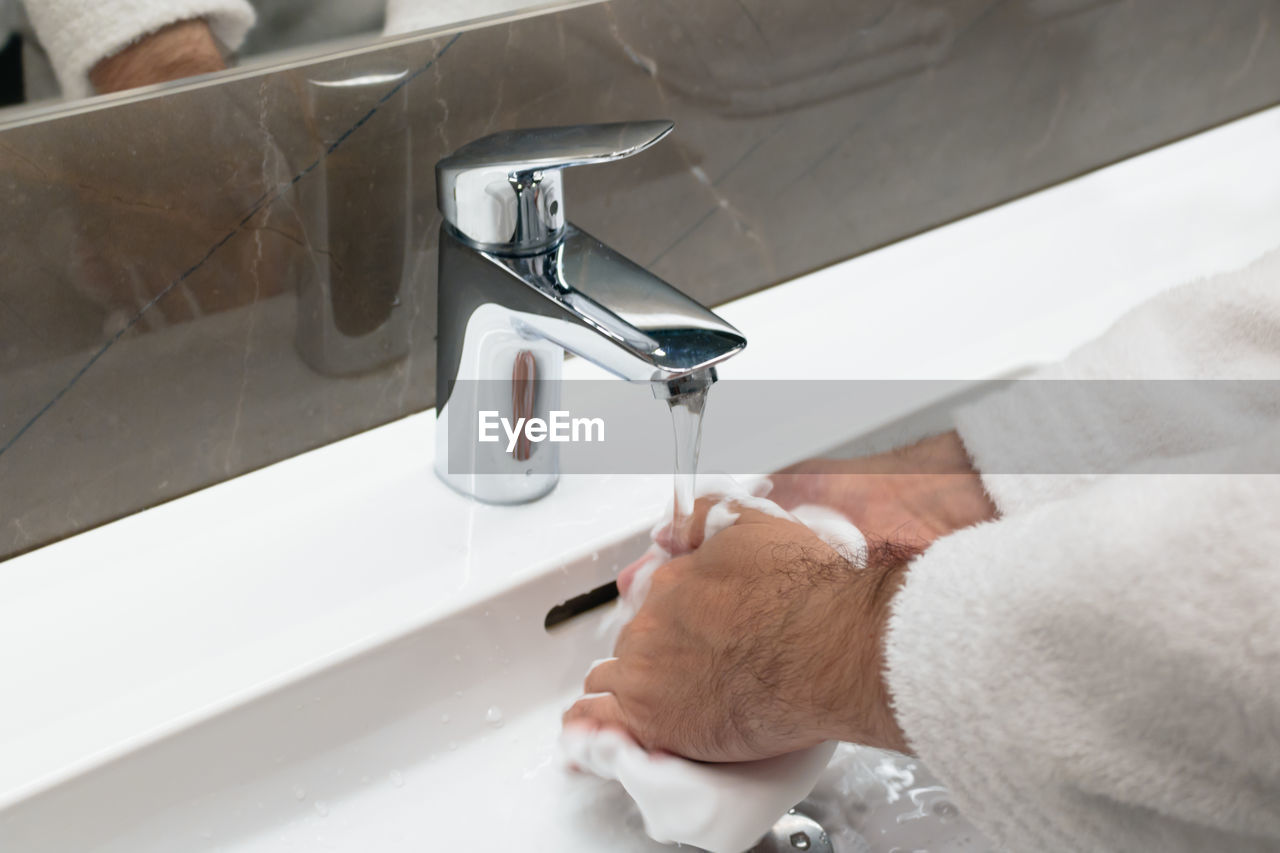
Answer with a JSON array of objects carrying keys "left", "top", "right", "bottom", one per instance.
[{"left": 0, "top": 517, "right": 980, "bottom": 853}]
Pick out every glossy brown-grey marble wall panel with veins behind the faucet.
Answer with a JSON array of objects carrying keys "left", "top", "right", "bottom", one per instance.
[{"left": 0, "top": 0, "right": 1280, "bottom": 560}]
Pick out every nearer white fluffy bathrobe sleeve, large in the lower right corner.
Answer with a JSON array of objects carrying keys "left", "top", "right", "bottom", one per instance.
[{"left": 886, "top": 448, "right": 1280, "bottom": 853}]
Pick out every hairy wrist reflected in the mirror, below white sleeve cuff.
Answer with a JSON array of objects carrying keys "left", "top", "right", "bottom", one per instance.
[{"left": 88, "top": 19, "right": 227, "bottom": 93}]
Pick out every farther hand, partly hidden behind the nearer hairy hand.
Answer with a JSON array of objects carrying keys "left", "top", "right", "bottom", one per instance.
[{"left": 769, "top": 432, "right": 996, "bottom": 549}]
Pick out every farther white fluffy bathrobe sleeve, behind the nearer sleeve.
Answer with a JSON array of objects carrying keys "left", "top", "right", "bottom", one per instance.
[{"left": 955, "top": 244, "right": 1280, "bottom": 516}]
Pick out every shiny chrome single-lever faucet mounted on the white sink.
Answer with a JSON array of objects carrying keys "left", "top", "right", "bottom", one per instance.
[{"left": 435, "top": 122, "right": 746, "bottom": 503}]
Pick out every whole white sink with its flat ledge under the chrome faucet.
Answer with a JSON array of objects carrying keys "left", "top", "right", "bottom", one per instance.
[{"left": 0, "top": 103, "right": 1280, "bottom": 853}]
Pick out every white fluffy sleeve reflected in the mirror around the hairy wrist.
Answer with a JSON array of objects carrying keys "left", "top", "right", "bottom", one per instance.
[{"left": 26, "top": 0, "right": 253, "bottom": 97}]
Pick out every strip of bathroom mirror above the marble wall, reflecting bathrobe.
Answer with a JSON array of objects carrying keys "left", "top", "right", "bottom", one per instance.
[{"left": 0, "top": 0, "right": 582, "bottom": 106}]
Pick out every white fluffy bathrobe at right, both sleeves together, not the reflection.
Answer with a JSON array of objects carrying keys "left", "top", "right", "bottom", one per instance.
[{"left": 886, "top": 242, "right": 1280, "bottom": 852}]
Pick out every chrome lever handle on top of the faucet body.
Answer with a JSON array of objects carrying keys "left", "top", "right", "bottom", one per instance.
[{"left": 435, "top": 120, "right": 675, "bottom": 255}]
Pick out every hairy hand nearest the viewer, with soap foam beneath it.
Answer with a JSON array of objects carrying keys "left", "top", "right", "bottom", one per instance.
[{"left": 564, "top": 500, "right": 908, "bottom": 761}]
